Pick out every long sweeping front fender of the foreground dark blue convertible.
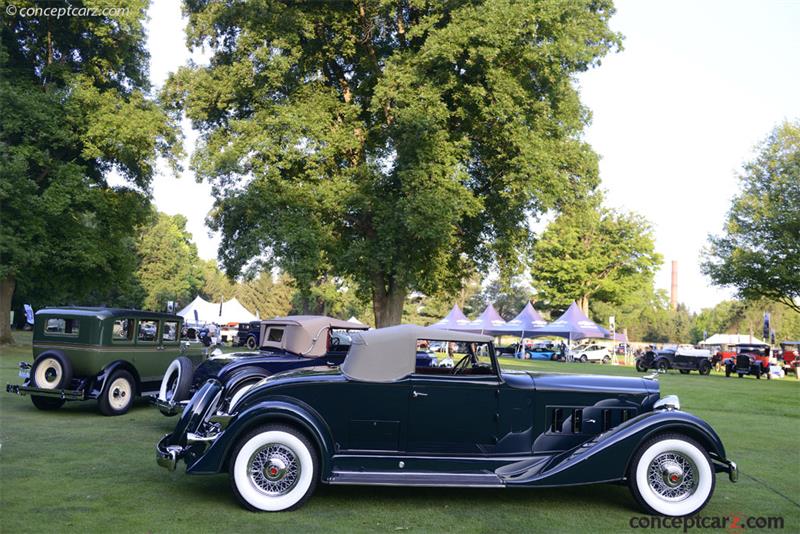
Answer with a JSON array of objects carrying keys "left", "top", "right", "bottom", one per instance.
[{"left": 504, "top": 410, "right": 727, "bottom": 486}]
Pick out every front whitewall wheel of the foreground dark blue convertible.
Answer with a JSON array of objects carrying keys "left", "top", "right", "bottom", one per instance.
[{"left": 629, "top": 434, "right": 716, "bottom": 517}]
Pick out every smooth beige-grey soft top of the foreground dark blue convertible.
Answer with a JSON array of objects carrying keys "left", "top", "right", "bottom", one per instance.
[{"left": 342, "top": 324, "right": 492, "bottom": 382}]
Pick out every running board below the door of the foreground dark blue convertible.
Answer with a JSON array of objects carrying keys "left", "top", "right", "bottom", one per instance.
[{"left": 327, "top": 471, "right": 505, "bottom": 488}]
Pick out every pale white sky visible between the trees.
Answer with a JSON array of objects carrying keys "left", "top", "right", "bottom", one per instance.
[{"left": 148, "top": 0, "right": 800, "bottom": 311}]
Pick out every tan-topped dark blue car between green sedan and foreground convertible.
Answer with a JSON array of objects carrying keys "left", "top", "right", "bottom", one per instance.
[{"left": 151, "top": 315, "right": 368, "bottom": 415}]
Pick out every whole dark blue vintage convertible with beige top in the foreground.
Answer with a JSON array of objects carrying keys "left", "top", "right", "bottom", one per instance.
[{"left": 156, "top": 325, "right": 738, "bottom": 517}]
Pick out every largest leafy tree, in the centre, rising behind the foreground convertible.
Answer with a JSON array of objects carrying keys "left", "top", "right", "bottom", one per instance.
[{"left": 164, "top": 0, "right": 620, "bottom": 326}]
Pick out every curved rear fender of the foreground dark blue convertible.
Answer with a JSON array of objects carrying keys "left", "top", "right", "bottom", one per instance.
[{"left": 186, "top": 397, "right": 335, "bottom": 479}]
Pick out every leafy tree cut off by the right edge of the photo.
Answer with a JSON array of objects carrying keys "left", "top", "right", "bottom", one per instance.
[{"left": 702, "top": 121, "right": 800, "bottom": 312}]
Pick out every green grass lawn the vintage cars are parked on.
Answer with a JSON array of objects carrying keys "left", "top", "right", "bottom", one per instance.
[{"left": 0, "top": 334, "right": 800, "bottom": 533}]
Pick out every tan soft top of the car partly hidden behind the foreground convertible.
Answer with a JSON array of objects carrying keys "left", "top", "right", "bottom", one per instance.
[{"left": 261, "top": 315, "right": 369, "bottom": 358}]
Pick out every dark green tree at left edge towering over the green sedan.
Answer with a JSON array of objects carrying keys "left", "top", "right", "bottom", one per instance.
[{"left": 0, "top": 0, "right": 175, "bottom": 342}]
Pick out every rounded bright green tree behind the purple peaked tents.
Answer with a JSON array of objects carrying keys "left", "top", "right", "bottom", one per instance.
[{"left": 531, "top": 194, "right": 661, "bottom": 313}]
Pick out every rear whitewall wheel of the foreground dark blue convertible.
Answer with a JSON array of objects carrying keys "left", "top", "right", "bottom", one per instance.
[{"left": 230, "top": 425, "right": 319, "bottom": 512}]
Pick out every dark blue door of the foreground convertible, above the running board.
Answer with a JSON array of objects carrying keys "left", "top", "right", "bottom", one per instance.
[{"left": 406, "top": 373, "right": 500, "bottom": 455}]
